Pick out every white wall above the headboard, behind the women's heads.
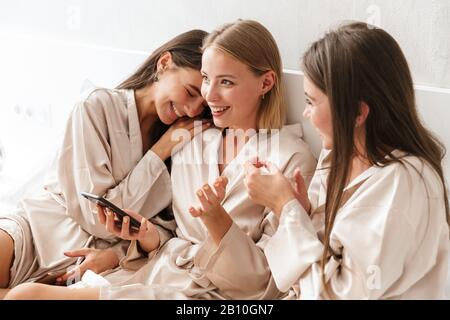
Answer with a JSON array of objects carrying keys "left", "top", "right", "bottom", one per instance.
[{"left": 0, "top": 0, "right": 450, "bottom": 88}]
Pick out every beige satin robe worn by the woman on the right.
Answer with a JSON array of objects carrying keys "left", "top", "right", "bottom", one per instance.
[{"left": 265, "top": 151, "right": 449, "bottom": 299}]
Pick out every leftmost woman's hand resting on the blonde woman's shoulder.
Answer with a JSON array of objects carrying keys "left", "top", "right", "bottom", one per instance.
[{"left": 150, "top": 118, "right": 211, "bottom": 161}]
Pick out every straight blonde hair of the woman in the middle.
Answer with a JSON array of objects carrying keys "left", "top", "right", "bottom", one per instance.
[{"left": 202, "top": 20, "right": 287, "bottom": 130}]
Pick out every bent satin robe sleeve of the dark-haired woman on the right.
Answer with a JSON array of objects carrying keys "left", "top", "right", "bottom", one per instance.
[{"left": 264, "top": 165, "right": 422, "bottom": 299}]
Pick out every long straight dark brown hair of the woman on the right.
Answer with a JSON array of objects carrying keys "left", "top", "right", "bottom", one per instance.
[{"left": 303, "top": 22, "right": 449, "bottom": 293}]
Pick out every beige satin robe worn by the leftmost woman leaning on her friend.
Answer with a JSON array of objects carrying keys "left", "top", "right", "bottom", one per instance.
[{"left": 0, "top": 88, "right": 171, "bottom": 287}]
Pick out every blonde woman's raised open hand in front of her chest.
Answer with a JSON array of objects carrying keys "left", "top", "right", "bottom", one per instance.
[{"left": 189, "top": 177, "right": 233, "bottom": 245}]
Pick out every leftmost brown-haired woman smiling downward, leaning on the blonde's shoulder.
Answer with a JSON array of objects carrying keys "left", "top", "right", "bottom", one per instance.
[{"left": 0, "top": 30, "right": 208, "bottom": 293}]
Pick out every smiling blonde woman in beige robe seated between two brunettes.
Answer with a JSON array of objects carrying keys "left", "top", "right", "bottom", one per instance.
[{"left": 4, "top": 20, "right": 316, "bottom": 299}]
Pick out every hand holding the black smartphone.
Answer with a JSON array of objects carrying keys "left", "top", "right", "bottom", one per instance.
[{"left": 97, "top": 205, "right": 160, "bottom": 252}]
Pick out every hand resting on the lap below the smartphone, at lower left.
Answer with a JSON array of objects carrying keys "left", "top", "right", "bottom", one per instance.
[{"left": 56, "top": 248, "right": 119, "bottom": 285}]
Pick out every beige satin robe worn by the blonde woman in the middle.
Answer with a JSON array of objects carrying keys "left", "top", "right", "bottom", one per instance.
[{"left": 96, "top": 125, "right": 316, "bottom": 299}]
